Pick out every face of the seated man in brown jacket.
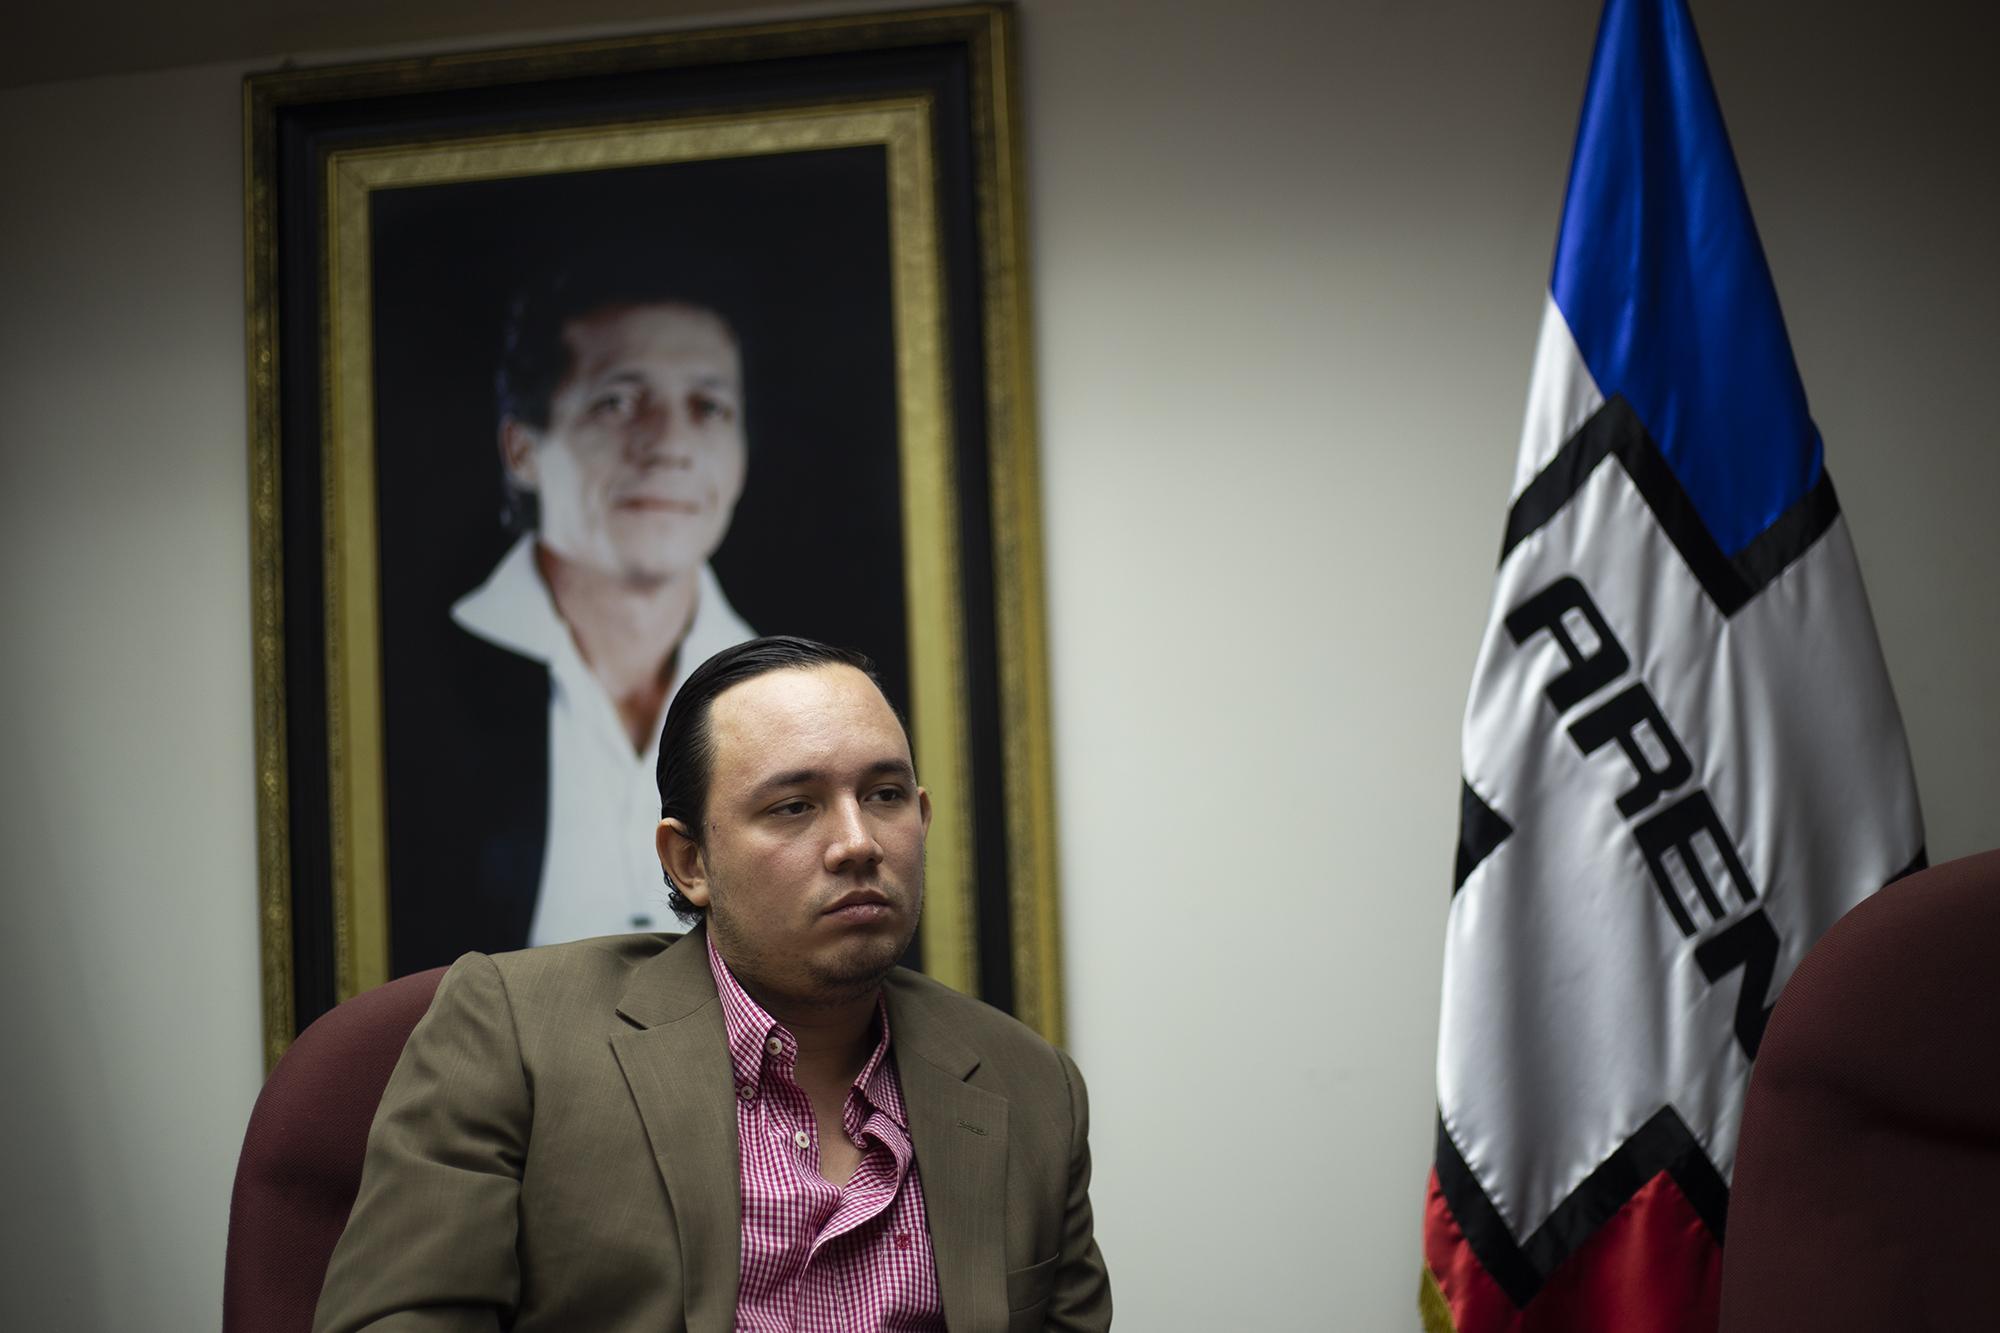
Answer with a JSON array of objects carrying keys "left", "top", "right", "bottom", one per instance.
[{"left": 662, "top": 664, "right": 930, "bottom": 1003}]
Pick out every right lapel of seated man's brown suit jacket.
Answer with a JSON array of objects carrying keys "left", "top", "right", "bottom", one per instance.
[{"left": 886, "top": 981, "right": 1008, "bottom": 1329}]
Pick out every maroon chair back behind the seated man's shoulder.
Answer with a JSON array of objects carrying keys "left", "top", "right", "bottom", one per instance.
[{"left": 222, "top": 967, "right": 444, "bottom": 1333}]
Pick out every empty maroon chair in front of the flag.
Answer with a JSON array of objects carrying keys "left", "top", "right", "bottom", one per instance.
[{"left": 1722, "top": 851, "right": 2000, "bottom": 1333}]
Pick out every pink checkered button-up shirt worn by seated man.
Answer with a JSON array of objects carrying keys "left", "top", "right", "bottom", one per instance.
[{"left": 708, "top": 941, "right": 944, "bottom": 1333}]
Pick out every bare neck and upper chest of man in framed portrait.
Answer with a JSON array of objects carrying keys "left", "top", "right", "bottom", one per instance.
[{"left": 534, "top": 542, "right": 700, "bottom": 749}]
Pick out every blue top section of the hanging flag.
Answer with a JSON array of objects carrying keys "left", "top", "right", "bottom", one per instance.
[{"left": 1550, "top": 0, "right": 1820, "bottom": 556}]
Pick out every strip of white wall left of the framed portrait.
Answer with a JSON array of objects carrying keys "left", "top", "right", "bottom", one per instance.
[{"left": 0, "top": 57, "right": 262, "bottom": 1329}]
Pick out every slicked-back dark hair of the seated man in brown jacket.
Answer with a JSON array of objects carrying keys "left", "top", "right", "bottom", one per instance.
[{"left": 654, "top": 634, "right": 910, "bottom": 923}]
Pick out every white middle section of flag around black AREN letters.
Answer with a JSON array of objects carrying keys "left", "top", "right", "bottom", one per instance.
[{"left": 1438, "top": 304, "right": 1922, "bottom": 1241}]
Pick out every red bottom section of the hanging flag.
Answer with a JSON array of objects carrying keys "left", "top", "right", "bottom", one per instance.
[{"left": 1424, "top": 1171, "right": 1722, "bottom": 1333}]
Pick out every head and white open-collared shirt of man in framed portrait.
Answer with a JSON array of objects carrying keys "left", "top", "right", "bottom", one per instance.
[{"left": 452, "top": 272, "right": 750, "bottom": 945}]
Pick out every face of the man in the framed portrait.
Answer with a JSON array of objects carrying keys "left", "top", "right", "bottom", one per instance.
[{"left": 500, "top": 306, "right": 746, "bottom": 582}]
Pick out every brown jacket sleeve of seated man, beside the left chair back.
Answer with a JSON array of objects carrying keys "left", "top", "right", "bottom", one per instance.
[{"left": 312, "top": 955, "right": 532, "bottom": 1333}]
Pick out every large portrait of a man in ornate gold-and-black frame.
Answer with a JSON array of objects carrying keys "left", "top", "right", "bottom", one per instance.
[{"left": 244, "top": 6, "right": 1062, "bottom": 1061}]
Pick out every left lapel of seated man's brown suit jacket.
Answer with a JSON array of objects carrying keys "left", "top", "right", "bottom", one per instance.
[{"left": 612, "top": 929, "right": 742, "bottom": 1333}]
